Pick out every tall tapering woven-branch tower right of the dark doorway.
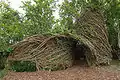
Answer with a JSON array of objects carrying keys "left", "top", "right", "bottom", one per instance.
[{"left": 74, "top": 8, "right": 112, "bottom": 65}]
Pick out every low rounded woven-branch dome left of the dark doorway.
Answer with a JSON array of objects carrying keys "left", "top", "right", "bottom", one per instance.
[{"left": 8, "top": 35, "right": 74, "bottom": 70}]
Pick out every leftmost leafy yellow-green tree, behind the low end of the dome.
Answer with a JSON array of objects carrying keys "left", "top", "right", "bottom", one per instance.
[{"left": 0, "top": 2, "right": 23, "bottom": 51}]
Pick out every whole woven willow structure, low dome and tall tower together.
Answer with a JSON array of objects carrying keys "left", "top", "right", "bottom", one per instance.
[{"left": 8, "top": 8, "right": 112, "bottom": 70}]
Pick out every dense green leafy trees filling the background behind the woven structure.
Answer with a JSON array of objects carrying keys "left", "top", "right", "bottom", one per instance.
[{"left": 0, "top": 0, "right": 120, "bottom": 72}]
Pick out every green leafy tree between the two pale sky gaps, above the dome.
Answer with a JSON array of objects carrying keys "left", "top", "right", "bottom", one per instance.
[{"left": 22, "top": 0, "right": 54, "bottom": 35}]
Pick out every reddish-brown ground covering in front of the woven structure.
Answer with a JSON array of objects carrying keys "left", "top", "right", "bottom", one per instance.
[{"left": 3, "top": 62, "right": 120, "bottom": 80}]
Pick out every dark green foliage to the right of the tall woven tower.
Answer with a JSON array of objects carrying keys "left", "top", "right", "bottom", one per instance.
[{"left": 105, "top": 0, "right": 120, "bottom": 49}]
